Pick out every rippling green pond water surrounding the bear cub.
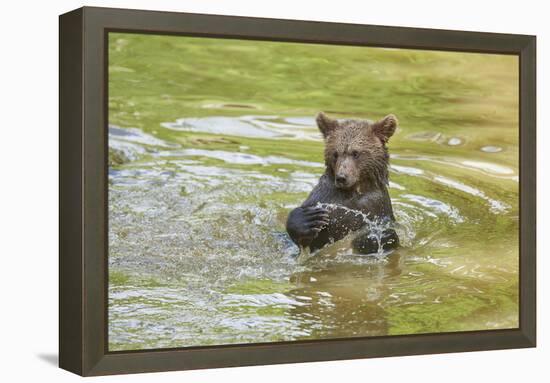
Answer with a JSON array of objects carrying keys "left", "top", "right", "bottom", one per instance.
[{"left": 108, "top": 33, "right": 519, "bottom": 351}]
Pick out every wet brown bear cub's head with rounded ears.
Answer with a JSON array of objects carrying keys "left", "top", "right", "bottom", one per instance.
[{"left": 317, "top": 112, "right": 397, "bottom": 191}]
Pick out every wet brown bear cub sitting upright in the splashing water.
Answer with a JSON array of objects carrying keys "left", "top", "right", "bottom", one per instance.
[{"left": 286, "top": 113, "right": 399, "bottom": 254}]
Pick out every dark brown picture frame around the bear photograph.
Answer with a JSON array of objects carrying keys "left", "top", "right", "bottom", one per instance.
[{"left": 59, "top": 7, "right": 536, "bottom": 376}]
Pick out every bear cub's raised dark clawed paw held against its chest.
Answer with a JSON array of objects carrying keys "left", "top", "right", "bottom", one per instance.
[{"left": 287, "top": 206, "right": 329, "bottom": 246}]
